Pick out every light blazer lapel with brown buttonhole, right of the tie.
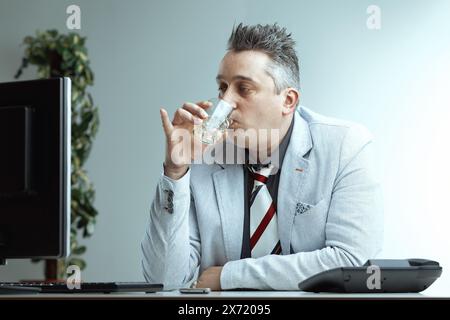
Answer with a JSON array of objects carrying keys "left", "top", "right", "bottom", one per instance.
[{"left": 277, "top": 111, "right": 312, "bottom": 254}]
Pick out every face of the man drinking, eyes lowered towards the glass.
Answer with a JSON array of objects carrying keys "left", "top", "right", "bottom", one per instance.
[{"left": 217, "top": 51, "right": 284, "bottom": 147}]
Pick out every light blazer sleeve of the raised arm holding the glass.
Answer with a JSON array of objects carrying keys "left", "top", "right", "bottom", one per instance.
[{"left": 141, "top": 169, "right": 200, "bottom": 290}]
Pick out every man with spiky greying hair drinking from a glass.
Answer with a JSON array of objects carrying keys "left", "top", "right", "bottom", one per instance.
[{"left": 142, "top": 24, "right": 382, "bottom": 290}]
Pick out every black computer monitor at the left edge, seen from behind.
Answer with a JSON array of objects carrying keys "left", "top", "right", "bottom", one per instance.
[{"left": 0, "top": 78, "right": 71, "bottom": 263}]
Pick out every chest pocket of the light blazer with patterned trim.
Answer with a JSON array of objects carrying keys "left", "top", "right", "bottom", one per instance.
[{"left": 291, "top": 199, "right": 328, "bottom": 252}]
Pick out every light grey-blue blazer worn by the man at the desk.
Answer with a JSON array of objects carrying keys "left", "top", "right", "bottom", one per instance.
[{"left": 141, "top": 107, "right": 383, "bottom": 290}]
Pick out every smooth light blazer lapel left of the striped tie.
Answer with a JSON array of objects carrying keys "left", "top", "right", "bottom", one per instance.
[{"left": 213, "top": 165, "right": 244, "bottom": 261}]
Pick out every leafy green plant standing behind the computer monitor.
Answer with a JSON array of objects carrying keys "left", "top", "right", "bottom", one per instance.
[{"left": 15, "top": 30, "right": 99, "bottom": 280}]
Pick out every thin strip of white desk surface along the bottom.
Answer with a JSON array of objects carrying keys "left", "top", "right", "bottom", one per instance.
[{"left": 0, "top": 291, "right": 450, "bottom": 300}]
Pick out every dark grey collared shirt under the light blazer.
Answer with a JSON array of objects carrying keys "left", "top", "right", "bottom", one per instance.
[{"left": 241, "top": 118, "right": 294, "bottom": 259}]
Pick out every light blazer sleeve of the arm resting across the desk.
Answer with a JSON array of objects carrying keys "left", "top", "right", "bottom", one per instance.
[{"left": 220, "top": 126, "right": 383, "bottom": 290}]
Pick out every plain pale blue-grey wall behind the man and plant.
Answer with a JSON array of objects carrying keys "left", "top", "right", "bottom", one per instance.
[{"left": 0, "top": 0, "right": 450, "bottom": 296}]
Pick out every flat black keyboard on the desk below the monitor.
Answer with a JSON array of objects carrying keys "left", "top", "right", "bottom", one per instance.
[{"left": 0, "top": 282, "right": 163, "bottom": 293}]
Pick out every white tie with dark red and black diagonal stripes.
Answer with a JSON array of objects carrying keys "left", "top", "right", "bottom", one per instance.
[{"left": 249, "top": 165, "right": 281, "bottom": 258}]
